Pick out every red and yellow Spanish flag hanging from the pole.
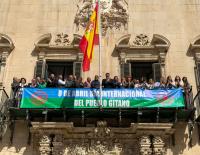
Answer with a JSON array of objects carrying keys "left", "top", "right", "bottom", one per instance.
[{"left": 79, "top": 3, "right": 99, "bottom": 72}]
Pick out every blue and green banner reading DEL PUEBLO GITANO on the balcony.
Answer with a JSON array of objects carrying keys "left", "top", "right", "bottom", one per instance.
[{"left": 20, "top": 88, "right": 184, "bottom": 109}]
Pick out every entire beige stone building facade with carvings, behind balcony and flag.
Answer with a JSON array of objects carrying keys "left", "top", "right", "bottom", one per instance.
[{"left": 0, "top": 0, "right": 200, "bottom": 155}]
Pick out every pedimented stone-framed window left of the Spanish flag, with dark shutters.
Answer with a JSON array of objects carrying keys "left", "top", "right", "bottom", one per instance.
[{"left": 34, "top": 33, "right": 83, "bottom": 78}]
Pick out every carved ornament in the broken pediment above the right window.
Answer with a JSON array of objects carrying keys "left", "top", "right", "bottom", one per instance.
[{"left": 133, "top": 34, "right": 150, "bottom": 46}]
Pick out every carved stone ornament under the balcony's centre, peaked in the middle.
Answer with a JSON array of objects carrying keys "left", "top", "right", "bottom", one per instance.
[{"left": 65, "top": 121, "right": 122, "bottom": 155}]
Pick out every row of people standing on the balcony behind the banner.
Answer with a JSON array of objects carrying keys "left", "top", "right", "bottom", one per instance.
[{"left": 11, "top": 73, "right": 192, "bottom": 108}]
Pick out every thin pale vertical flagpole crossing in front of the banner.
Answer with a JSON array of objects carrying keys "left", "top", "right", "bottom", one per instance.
[{"left": 98, "top": 0, "right": 102, "bottom": 109}]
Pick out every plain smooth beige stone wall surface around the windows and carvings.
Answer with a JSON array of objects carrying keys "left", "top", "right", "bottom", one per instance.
[{"left": 0, "top": 0, "right": 200, "bottom": 155}]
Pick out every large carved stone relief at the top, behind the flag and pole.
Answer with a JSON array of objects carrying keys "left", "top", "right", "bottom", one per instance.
[{"left": 74, "top": 0, "right": 128, "bottom": 35}]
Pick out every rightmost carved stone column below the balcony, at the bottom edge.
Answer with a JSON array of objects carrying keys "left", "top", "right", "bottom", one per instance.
[{"left": 152, "top": 136, "right": 166, "bottom": 155}]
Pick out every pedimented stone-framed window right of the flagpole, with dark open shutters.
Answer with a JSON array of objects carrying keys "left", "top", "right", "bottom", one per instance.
[{"left": 115, "top": 34, "right": 170, "bottom": 81}]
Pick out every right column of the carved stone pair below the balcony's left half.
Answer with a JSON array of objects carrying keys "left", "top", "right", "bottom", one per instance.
[{"left": 52, "top": 134, "right": 64, "bottom": 155}]
